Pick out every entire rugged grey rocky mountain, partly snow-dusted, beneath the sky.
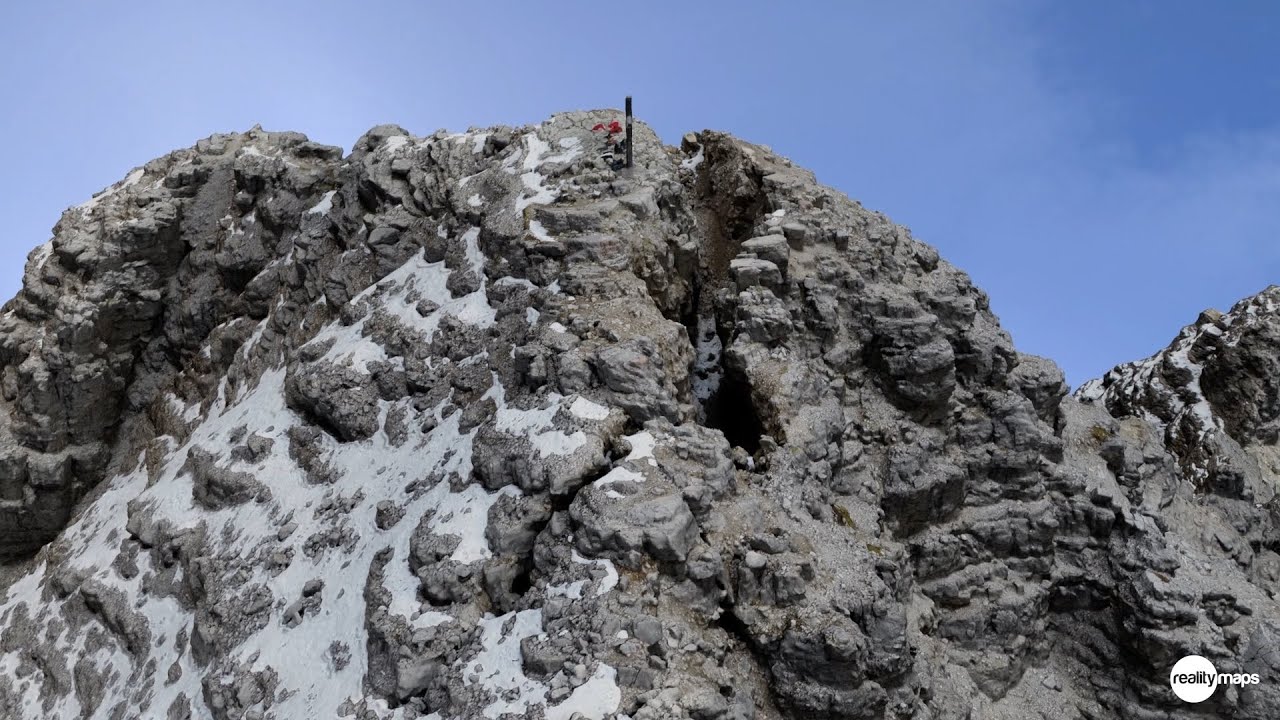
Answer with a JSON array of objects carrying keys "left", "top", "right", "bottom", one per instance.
[{"left": 0, "top": 111, "right": 1280, "bottom": 720}]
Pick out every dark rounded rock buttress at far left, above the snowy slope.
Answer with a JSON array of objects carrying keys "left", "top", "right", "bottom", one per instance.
[{"left": 0, "top": 131, "right": 340, "bottom": 557}]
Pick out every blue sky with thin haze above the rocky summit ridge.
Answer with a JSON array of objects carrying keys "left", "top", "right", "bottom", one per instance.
[{"left": 0, "top": 0, "right": 1280, "bottom": 384}]
